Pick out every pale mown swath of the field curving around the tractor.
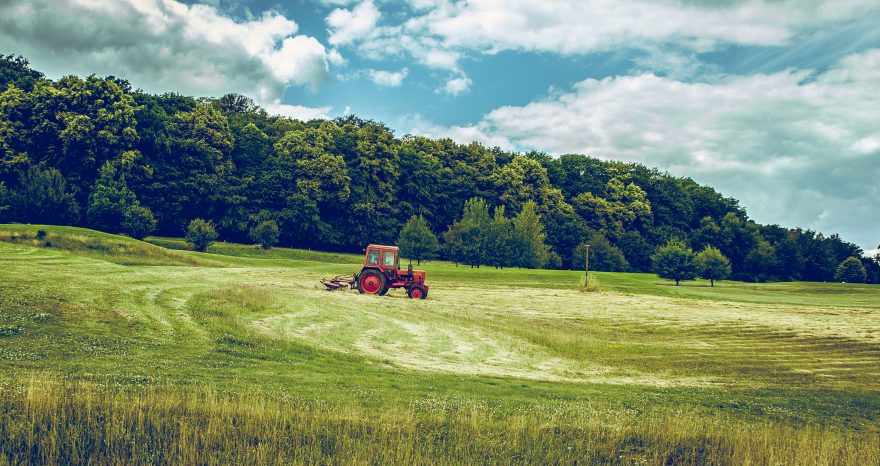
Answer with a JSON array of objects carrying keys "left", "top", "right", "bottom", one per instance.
[{"left": 0, "top": 238, "right": 880, "bottom": 389}]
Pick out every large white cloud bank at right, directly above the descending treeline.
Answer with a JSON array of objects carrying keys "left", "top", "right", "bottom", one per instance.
[{"left": 413, "top": 49, "right": 880, "bottom": 249}]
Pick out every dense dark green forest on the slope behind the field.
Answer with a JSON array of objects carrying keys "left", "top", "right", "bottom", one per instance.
[{"left": 0, "top": 55, "right": 880, "bottom": 283}]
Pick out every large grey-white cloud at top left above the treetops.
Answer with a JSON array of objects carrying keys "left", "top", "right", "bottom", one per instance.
[{"left": 0, "top": 0, "right": 341, "bottom": 114}]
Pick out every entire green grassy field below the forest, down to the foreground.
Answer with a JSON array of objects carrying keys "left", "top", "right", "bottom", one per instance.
[{"left": 0, "top": 225, "right": 880, "bottom": 464}]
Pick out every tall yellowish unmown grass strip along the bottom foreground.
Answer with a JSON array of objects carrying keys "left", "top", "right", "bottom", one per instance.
[{"left": 0, "top": 380, "right": 880, "bottom": 465}]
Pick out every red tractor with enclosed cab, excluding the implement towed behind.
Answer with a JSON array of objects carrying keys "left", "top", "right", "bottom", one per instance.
[{"left": 354, "top": 244, "right": 428, "bottom": 299}]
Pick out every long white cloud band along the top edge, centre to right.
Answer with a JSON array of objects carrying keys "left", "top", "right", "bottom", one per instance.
[{"left": 327, "top": 0, "right": 880, "bottom": 78}]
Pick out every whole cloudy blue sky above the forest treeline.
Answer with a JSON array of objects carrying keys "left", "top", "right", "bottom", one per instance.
[{"left": 0, "top": 0, "right": 880, "bottom": 255}]
